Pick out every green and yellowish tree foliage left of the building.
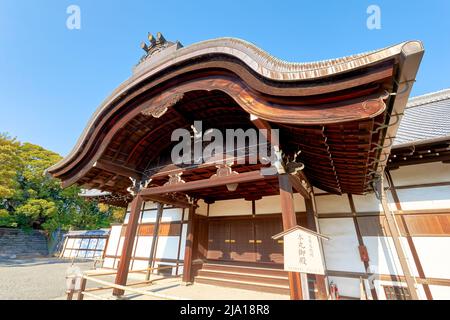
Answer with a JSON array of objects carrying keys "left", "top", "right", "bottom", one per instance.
[{"left": 0, "top": 134, "right": 124, "bottom": 232}]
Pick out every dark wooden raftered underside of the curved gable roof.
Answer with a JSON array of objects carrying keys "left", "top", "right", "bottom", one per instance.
[{"left": 66, "top": 85, "right": 385, "bottom": 200}]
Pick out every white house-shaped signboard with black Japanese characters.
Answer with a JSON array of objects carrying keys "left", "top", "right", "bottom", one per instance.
[{"left": 274, "top": 226, "right": 328, "bottom": 275}]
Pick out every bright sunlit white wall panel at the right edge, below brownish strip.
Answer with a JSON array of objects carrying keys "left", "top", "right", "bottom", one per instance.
[{"left": 413, "top": 237, "right": 450, "bottom": 278}]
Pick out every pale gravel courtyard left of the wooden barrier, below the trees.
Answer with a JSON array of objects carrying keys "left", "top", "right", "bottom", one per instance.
[{"left": 0, "top": 258, "right": 93, "bottom": 300}]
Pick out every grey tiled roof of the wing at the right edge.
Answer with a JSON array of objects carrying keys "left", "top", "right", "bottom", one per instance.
[{"left": 394, "top": 89, "right": 450, "bottom": 146}]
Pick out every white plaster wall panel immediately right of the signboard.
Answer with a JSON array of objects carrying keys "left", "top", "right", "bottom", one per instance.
[{"left": 319, "top": 218, "right": 364, "bottom": 272}]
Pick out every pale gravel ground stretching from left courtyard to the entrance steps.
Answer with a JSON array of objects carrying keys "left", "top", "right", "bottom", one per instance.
[{"left": 0, "top": 258, "right": 289, "bottom": 300}]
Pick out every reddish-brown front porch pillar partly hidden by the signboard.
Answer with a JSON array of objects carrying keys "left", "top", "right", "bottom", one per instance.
[{"left": 278, "top": 174, "right": 303, "bottom": 300}]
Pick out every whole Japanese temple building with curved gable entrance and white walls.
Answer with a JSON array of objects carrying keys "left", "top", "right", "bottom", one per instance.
[{"left": 48, "top": 33, "right": 450, "bottom": 299}]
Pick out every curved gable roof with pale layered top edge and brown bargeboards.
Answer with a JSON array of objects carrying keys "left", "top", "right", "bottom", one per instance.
[{"left": 48, "top": 38, "right": 423, "bottom": 193}]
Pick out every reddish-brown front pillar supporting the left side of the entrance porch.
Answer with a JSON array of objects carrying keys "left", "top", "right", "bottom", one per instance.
[{"left": 113, "top": 195, "right": 142, "bottom": 296}]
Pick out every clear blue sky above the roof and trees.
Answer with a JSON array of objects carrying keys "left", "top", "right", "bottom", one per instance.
[{"left": 0, "top": 0, "right": 450, "bottom": 155}]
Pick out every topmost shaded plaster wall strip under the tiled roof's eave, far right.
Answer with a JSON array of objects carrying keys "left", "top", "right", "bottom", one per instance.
[{"left": 391, "top": 162, "right": 450, "bottom": 187}]
